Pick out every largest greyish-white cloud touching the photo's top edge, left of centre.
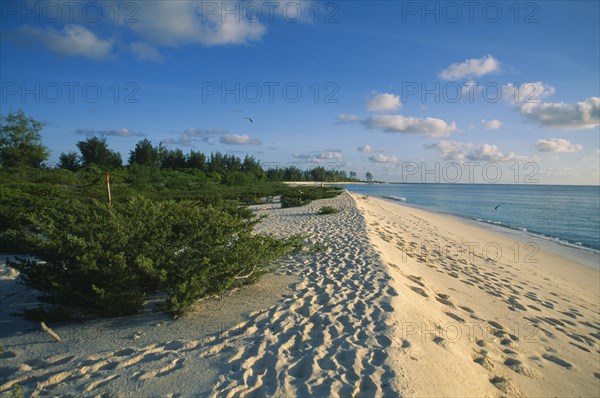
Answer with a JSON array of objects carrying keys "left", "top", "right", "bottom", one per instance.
[{"left": 126, "top": 0, "right": 266, "bottom": 46}]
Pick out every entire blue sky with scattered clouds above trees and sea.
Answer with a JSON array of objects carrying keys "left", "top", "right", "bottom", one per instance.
[{"left": 0, "top": 0, "right": 600, "bottom": 185}]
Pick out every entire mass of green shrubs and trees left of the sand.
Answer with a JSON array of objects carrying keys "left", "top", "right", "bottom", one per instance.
[{"left": 0, "top": 111, "right": 356, "bottom": 316}]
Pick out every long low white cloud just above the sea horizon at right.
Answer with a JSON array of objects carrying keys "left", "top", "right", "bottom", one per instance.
[{"left": 425, "top": 141, "right": 530, "bottom": 162}]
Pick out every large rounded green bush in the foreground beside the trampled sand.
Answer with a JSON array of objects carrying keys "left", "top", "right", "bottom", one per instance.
[{"left": 10, "top": 197, "right": 301, "bottom": 315}]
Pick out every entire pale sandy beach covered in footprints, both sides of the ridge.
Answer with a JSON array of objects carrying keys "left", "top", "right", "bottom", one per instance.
[{"left": 0, "top": 193, "right": 600, "bottom": 397}]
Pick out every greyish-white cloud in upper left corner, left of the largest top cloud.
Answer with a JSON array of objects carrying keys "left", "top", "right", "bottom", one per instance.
[{"left": 12, "top": 25, "right": 112, "bottom": 59}]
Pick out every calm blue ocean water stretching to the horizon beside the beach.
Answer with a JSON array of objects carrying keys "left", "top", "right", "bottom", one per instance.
[{"left": 340, "top": 183, "right": 600, "bottom": 252}]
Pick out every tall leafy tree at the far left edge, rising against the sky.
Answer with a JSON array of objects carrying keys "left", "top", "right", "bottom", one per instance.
[{"left": 0, "top": 110, "right": 50, "bottom": 167}]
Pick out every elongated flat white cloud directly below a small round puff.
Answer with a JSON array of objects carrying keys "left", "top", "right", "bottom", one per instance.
[{"left": 363, "top": 115, "right": 456, "bottom": 137}]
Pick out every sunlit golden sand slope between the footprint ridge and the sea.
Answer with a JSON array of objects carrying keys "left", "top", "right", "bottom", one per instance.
[{"left": 355, "top": 195, "right": 600, "bottom": 397}]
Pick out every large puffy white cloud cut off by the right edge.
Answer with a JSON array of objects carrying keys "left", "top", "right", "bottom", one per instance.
[{"left": 518, "top": 97, "right": 600, "bottom": 129}]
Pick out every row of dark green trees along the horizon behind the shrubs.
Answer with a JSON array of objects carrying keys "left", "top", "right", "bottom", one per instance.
[{"left": 0, "top": 110, "right": 366, "bottom": 182}]
